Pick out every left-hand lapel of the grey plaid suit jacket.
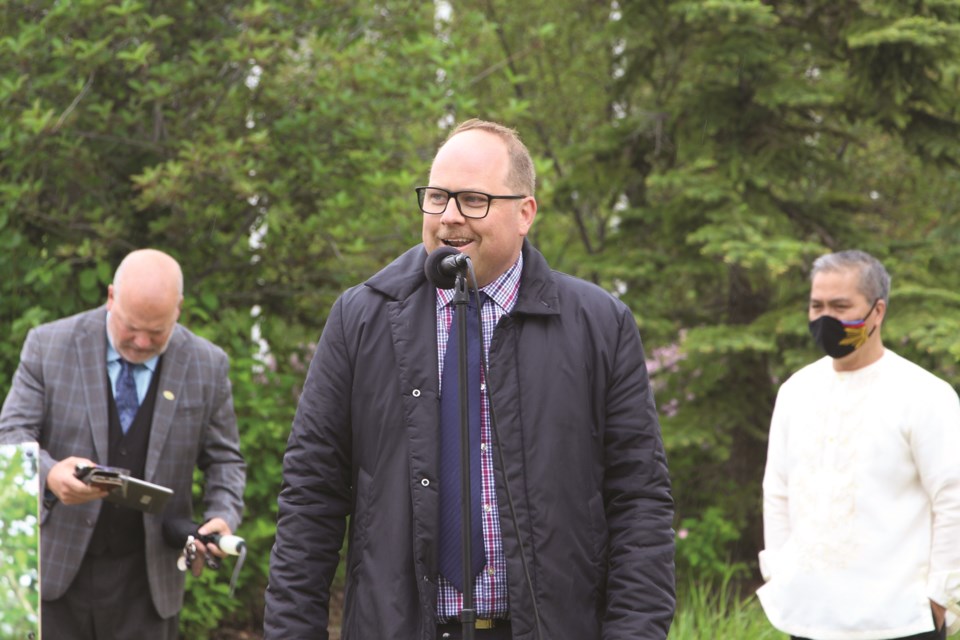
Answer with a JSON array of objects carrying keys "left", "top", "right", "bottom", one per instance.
[{"left": 76, "top": 308, "right": 110, "bottom": 464}]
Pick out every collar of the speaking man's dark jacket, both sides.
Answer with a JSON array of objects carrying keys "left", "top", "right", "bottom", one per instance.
[{"left": 364, "top": 239, "right": 560, "bottom": 315}]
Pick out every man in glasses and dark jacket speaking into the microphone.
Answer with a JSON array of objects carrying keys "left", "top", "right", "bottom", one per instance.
[{"left": 264, "top": 120, "right": 675, "bottom": 640}]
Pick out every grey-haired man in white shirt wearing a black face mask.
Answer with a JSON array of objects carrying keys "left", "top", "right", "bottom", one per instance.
[{"left": 757, "top": 251, "right": 960, "bottom": 640}]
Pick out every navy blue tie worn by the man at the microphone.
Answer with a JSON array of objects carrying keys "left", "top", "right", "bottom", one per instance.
[{"left": 439, "top": 292, "right": 486, "bottom": 592}]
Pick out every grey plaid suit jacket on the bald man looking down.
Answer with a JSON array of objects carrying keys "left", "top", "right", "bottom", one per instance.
[{"left": 0, "top": 307, "right": 246, "bottom": 618}]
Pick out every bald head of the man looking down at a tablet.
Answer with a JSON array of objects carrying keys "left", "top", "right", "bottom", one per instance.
[{"left": 107, "top": 249, "right": 183, "bottom": 363}]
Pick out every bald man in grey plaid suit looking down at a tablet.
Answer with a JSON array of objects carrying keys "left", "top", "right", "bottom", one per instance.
[{"left": 0, "top": 249, "right": 246, "bottom": 640}]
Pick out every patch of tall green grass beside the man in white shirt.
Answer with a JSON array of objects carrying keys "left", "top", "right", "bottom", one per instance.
[{"left": 668, "top": 582, "right": 789, "bottom": 640}]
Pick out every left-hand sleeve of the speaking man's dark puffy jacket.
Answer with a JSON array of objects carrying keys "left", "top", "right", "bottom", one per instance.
[{"left": 264, "top": 300, "right": 352, "bottom": 640}]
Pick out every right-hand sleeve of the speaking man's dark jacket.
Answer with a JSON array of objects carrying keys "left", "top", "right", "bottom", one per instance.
[{"left": 603, "top": 308, "right": 676, "bottom": 640}]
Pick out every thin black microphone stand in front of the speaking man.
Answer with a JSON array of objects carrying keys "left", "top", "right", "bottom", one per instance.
[{"left": 447, "top": 269, "right": 483, "bottom": 640}]
